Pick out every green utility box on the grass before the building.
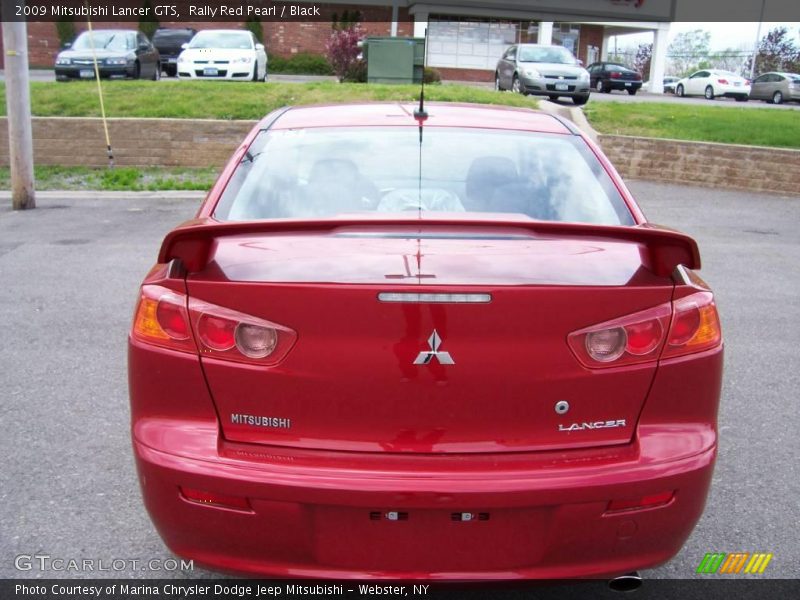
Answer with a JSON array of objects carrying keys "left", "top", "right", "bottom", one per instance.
[{"left": 363, "top": 37, "right": 425, "bottom": 83}]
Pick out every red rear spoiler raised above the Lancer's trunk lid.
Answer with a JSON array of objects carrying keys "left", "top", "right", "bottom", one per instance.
[{"left": 158, "top": 217, "right": 700, "bottom": 277}]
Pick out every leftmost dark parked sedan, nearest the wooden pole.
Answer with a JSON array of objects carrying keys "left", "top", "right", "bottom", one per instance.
[{"left": 55, "top": 29, "right": 161, "bottom": 81}]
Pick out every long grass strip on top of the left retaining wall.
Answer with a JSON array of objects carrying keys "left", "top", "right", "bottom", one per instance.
[{"left": 0, "top": 81, "right": 537, "bottom": 119}]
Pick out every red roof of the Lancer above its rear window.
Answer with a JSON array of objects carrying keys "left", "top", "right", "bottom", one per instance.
[{"left": 263, "top": 102, "right": 573, "bottom": 134}]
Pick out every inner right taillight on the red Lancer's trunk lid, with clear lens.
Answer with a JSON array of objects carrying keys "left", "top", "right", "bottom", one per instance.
[{"left": 568, "top": 304, "right": 671, "bottom": 368}]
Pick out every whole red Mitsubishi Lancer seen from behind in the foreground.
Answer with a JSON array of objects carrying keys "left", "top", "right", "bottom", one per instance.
[{"left": 129, "top": 104, "right": 723, "bottom": 580}]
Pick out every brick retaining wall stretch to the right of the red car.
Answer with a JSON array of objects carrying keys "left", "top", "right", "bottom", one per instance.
[{"left": 599, "top": 134, "right": 800, "bottom": 196}]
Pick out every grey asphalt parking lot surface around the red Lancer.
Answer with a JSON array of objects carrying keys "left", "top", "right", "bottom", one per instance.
[{"left": 0, "top": 182, "right": 800, "bottom": 578}]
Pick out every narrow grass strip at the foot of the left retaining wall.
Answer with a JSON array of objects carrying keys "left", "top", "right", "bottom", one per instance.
[{"left": 0, "top": 166, "right": 219, "bottom": 192}]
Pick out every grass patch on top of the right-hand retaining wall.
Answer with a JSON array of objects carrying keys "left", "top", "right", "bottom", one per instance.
[{"left": 584, "top": 100, "right": 800, "bottom": 148}]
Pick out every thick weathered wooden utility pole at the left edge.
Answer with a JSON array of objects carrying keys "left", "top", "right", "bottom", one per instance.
[{"left": 2, "top": 0, "right": 36, "bottom": 210}]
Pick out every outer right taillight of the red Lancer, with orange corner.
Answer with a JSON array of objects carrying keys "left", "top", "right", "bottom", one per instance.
[{"left": 664, "top": 292, "right": 722, "bottom": 357}]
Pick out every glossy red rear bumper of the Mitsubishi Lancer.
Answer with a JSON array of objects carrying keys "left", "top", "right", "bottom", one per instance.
[{"left": 134, "top": 419, "right": 716, "bottom": 580}]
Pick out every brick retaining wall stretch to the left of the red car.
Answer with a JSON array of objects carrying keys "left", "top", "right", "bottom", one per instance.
[{"left": 0, "top": 117, "right": 255, "bottom": 167}]
